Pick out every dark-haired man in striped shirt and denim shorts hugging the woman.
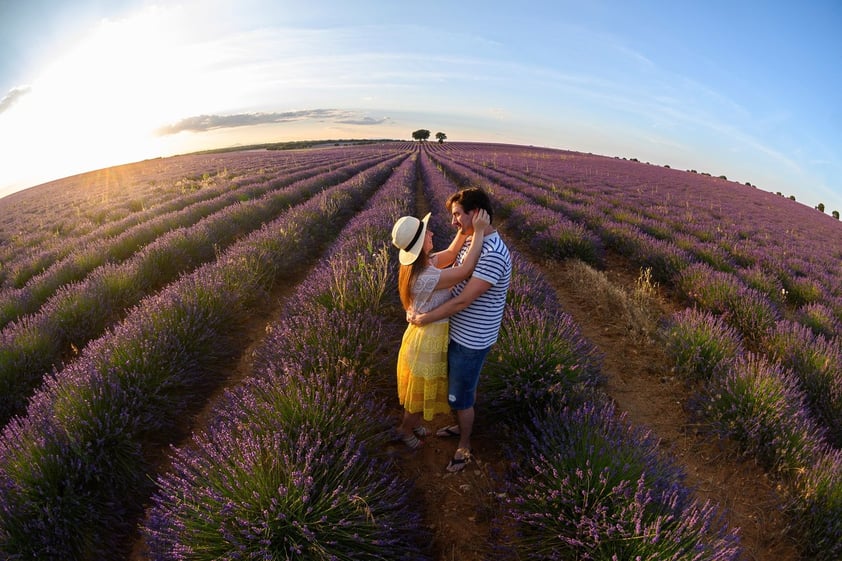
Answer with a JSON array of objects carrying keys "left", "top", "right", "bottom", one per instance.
[{"left": 408, "top": 187, "right": 512, "bottom": 472}]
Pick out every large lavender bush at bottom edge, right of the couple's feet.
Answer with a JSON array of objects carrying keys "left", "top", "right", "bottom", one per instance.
[{"left": 502, "top": 402, "right": 740, "bottom": 561}]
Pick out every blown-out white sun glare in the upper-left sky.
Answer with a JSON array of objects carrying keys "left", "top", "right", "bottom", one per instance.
[{"left": 0, "top": 3, "right": 213, "bottom": 192}]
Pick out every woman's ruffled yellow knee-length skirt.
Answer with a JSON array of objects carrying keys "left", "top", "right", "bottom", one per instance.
[{"left": 398, "top": 322, "right": 450, "bottom": 421}]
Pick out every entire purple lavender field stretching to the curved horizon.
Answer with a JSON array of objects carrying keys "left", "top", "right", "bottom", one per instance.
[{"left": 0, "top": 142, "right": 842, "bottom": 561}]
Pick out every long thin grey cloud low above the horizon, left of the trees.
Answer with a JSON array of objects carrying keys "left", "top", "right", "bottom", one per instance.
[{"left": 157, "top": 109, "right": 370, "bottom": 136}]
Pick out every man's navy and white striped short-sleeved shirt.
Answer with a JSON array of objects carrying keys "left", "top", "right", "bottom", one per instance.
[{"left": 450, "top": 232, "right": 512, "bottom": 349}]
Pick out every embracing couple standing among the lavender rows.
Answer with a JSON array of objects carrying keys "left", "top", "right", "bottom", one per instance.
[{"left": 392, "top": 187, "right": 512, "bottom": 472}]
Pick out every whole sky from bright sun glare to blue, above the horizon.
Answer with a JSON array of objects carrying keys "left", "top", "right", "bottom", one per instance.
[{"left": 0, "top": 0, "right": 842, "bottom": 213}]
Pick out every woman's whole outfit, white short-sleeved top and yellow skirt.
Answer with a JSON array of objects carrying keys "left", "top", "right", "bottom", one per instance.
[{"left": 398, "top": 265, "right": 450, "bottom": 421}]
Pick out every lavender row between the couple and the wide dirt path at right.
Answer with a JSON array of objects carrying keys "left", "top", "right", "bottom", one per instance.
[{"left": 421, "top": 147, "right": 739, "bottom": 561}]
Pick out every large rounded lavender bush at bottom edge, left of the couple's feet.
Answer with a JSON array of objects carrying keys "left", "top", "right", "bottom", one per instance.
[{"left": 144, "top": 424, "right": 426, "bottom": 561}]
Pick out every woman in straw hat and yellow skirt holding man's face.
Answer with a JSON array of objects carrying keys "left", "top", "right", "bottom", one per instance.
[{"left": 392, "top": 209, "right": 490, "bottom": 449}]
